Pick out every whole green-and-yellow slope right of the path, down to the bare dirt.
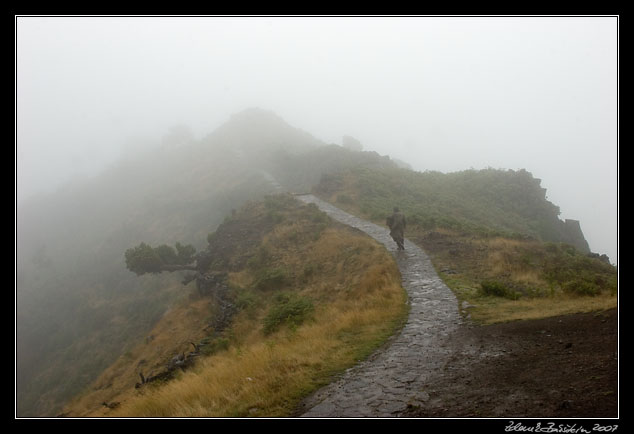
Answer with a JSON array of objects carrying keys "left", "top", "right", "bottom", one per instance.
[{"left": 315, "top": 169, "right": 617, "bottom": 323}]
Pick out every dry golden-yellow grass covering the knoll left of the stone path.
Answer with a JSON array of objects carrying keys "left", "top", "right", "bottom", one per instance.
[{"left": 66, "top": 220, "right": 407, "bottom": 417}]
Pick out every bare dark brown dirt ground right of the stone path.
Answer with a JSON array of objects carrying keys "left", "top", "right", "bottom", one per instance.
[{"left": 402, "top": 309, "right": 619, "bottom": 418}]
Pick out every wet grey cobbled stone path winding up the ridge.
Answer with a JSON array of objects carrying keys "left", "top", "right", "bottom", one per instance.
[{"left": 297, "top": 195, "right": 462, "bottom": 418}]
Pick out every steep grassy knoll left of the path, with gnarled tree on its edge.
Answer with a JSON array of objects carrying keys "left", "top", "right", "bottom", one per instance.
[{"left": 64, "top": 195, "right": 407, "bottom": 417}]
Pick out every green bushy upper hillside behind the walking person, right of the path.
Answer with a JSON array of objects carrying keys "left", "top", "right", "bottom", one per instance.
[{"left": 316, "top": 168, "right": 588, "bottom": 251}]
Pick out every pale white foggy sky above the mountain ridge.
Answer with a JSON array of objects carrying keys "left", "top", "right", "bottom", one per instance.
[{"left": 15, "top": 16, "right": 618, "bottom": 263}]
